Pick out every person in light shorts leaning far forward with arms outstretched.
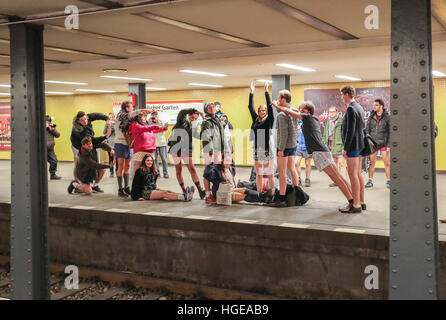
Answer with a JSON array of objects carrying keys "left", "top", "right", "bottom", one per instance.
[{"left": 273, "top": 101, "right": 353, "bottom": 211}]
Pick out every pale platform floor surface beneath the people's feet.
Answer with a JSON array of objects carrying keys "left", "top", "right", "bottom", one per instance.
[{"left": 0, "top": 160, "right": 446, "bottom": 235}]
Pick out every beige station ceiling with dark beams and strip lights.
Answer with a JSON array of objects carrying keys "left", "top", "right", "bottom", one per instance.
[{"left": 0, "top": 0, "right": 446, "bottom": 93}]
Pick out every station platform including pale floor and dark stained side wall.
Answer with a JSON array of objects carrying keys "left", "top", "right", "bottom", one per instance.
[{"left": 0, "top": 161, "right": 446, "bottom": 299}]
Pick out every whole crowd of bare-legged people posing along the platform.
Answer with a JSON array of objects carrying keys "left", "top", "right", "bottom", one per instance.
[{"left": 41, "top": 83, "right": 389, "bottom": 213}]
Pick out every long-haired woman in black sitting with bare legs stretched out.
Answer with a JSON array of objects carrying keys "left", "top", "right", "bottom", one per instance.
[{"left": 130, "top": 154, "right": 195, "bottom": 201}]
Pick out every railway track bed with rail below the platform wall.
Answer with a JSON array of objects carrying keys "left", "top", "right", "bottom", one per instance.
[{"left": 0, "top": 257, "right": 279, "bottom": 300}]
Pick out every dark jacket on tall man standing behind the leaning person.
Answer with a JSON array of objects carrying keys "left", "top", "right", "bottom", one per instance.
[{"left": 341, "top": 100, "right": 364, "bottom": 152}]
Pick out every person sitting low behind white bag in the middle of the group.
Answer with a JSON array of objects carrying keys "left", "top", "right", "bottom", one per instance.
[{"left": 203, "top": 157, "right": 267, "bottom": 203}]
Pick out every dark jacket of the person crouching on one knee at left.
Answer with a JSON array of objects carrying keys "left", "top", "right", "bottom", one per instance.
[{"left": 76, "top": 142, "right": 111, "bottom": 183}]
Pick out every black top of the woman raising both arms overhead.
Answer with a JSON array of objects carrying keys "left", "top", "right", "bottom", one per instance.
[{"left": 248, "top": 92, "right": 274, "bottom": 151}]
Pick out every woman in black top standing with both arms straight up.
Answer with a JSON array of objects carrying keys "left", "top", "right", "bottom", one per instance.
[{"left": 248, "top": 81, "right": 275, "bottom": 202}]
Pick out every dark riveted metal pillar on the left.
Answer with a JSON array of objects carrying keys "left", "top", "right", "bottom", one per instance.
[{"left": 10, "top": 24, "right": 49, "bottom": 299}]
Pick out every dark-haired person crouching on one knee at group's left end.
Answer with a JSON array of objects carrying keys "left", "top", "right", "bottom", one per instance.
[{"left": 68, "top": 136, "right": 116, "bottom": 195}]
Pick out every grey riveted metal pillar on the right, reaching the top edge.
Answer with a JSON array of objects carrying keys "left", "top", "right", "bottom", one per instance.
[{"left": 389, "top": 0, "right": 439, "bottom": 299}]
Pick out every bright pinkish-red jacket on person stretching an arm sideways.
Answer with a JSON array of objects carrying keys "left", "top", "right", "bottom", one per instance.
[{"left": 129, "top": 121, "right": 167, "bottom": 153}]
